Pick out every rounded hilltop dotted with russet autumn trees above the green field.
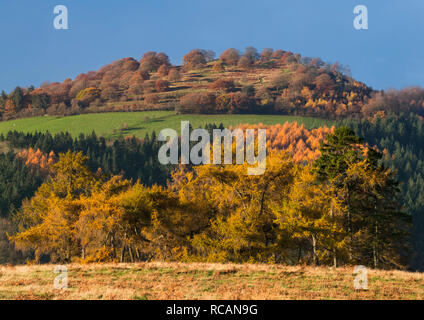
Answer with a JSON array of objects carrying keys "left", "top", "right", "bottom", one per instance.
[{"left": 0, "top": 47, "right": 373, "bottom": 120}]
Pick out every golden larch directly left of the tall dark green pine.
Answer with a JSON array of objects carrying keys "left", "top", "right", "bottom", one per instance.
[{"left": 275, "top": 166, "right": 346, "bottom": 265}]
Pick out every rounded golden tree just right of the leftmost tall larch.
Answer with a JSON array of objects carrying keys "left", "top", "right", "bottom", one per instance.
[{"left": 74, "top": 176, "right": 152, "bottom": 262}]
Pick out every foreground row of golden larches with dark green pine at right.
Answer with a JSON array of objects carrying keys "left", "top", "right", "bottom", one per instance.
[{"left": 10, "top": 127, "right": 410, "bottom": 268}]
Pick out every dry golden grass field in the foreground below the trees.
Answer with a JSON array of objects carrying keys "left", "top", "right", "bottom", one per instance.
[{"left": 0, "top": 262, "right": 424, "bottom": 300}]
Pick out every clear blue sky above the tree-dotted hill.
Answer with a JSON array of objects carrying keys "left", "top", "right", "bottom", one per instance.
[{"left": 0, "top": 0, "right": 424, "bottom": 91}]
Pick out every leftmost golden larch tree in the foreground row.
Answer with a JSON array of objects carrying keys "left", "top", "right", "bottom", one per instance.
[{"left": 11, "top": 152, "right": 96, "bottom": 262}]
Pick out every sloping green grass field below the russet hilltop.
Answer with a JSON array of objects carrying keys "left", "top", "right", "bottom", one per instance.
[{"left": 0, "top": 111, "right": 333, "bottom": 138}]
